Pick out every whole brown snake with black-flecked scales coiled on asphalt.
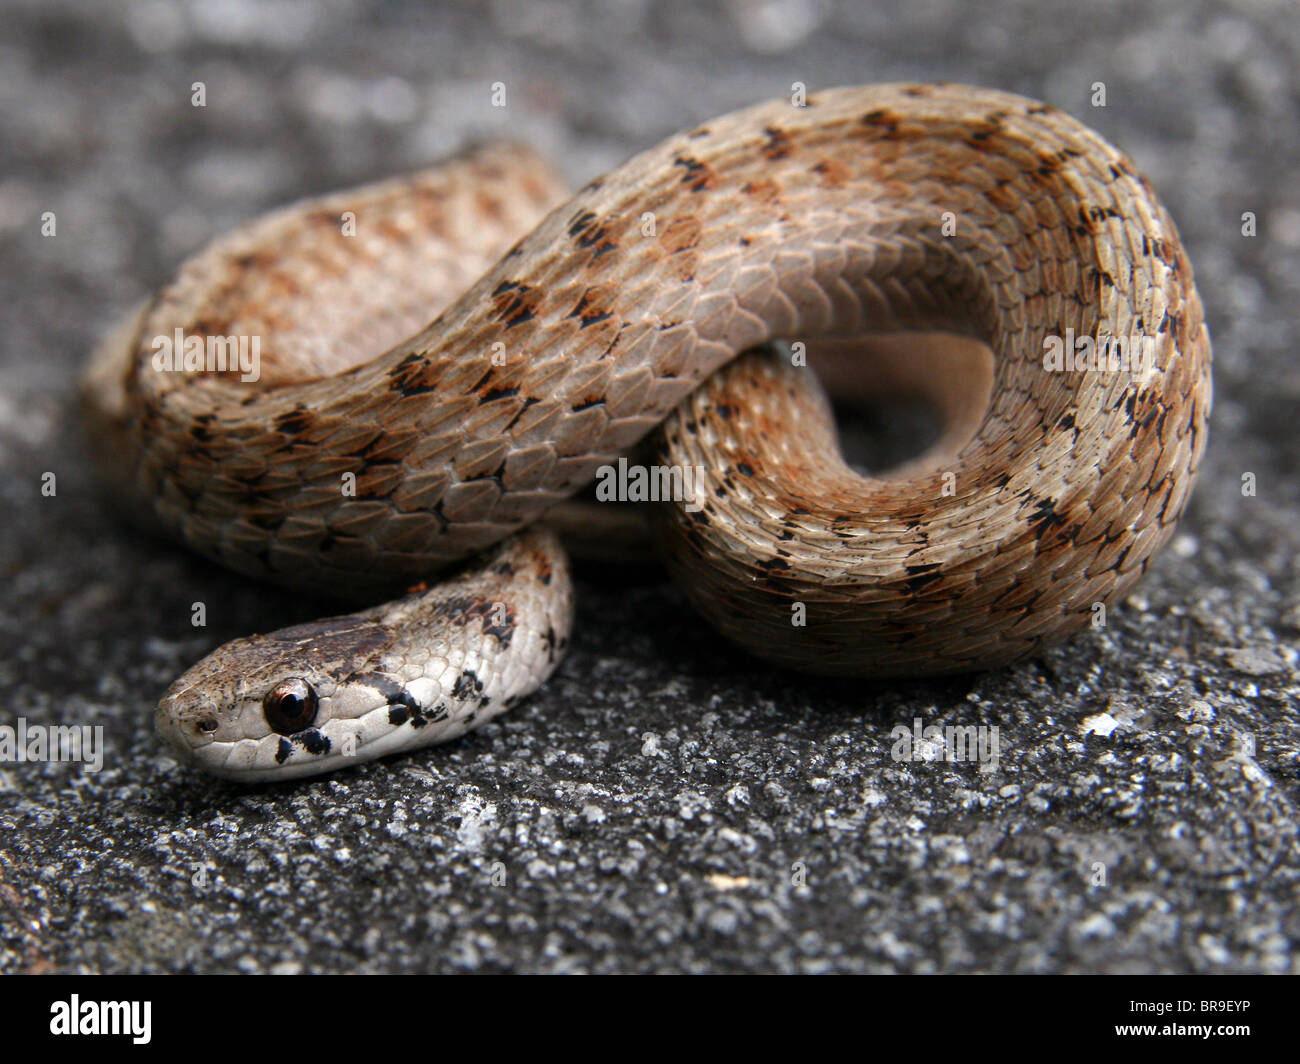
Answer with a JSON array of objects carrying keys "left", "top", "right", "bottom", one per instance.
[{"left": 82, "top": 83, "right": 1212, "bottom": 783}]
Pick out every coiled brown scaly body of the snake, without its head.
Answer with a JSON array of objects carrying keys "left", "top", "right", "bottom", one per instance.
[{"left": 90, "top": 86, "right": 1210, "bottom": 674}]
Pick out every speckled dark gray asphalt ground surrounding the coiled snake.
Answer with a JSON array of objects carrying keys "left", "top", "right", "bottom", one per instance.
[{"left": 0, "top": 0, "right": 1300, "bottom": 973}]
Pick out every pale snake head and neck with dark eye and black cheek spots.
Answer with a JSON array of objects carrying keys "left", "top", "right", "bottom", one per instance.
[{"left": 155, "top": 529, "right": 573, "bottom": 783}]
